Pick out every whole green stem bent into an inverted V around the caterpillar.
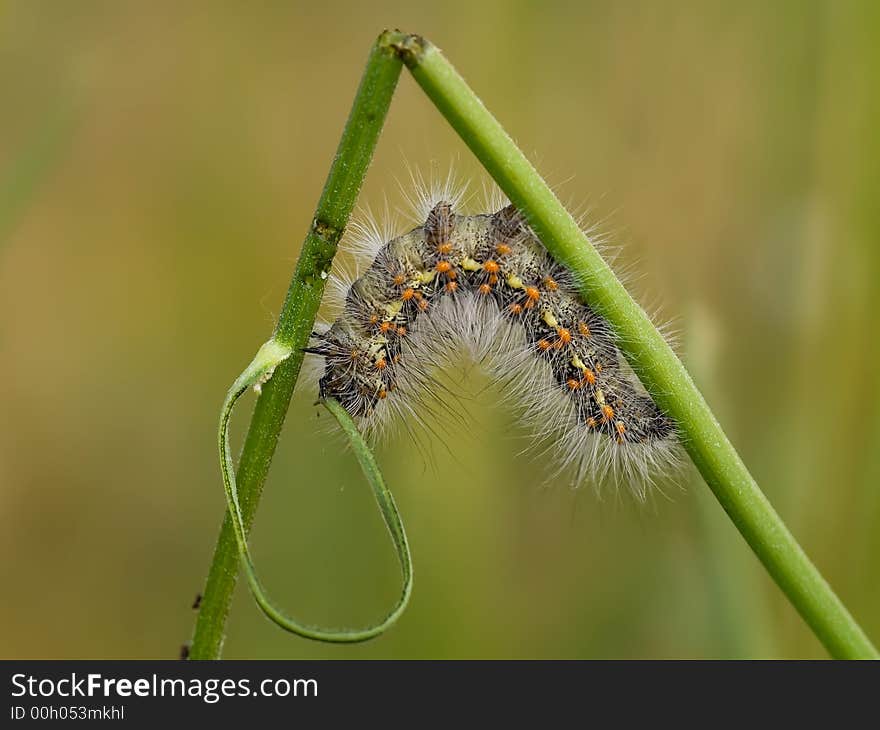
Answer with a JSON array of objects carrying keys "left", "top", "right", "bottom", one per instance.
[{"left": 190, "top": 32, "right": 880, "bottom": 658}]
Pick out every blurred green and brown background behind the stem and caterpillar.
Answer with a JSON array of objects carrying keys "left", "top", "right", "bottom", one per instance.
[{"left": 0, "top": 0, "right": 880, "bottom": 658}]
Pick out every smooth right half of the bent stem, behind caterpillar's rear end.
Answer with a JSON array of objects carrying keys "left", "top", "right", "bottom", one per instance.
[{"left": 388, "top": 36, "right": 878, "bottom": 658}]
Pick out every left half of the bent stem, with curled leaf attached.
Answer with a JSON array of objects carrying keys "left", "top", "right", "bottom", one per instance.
[{"left": 189, "top": 34, "right": 402, "bottom": 659}]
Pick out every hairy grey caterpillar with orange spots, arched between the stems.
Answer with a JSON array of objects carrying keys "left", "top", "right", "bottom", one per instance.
[{"left": 306, "top": 181, "right": 680, "bottom": 499}]
